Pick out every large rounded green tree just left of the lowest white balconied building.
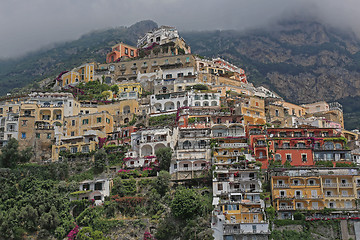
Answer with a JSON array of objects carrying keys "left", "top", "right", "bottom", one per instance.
[{"left": 170, "top": 187, "right": 201, "bottom": 220}]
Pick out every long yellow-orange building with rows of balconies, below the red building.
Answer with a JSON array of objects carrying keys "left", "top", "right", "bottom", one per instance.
[{"left": 271, "top": 168, "right": 360, "bottom": 218}]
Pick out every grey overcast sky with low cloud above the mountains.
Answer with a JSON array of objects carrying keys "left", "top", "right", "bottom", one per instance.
[{"left": 0, "top": 0, "right": 360, "bottom": 58}]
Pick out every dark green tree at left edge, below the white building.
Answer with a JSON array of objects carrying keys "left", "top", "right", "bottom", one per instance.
[{"left": 0, "top": 138, "right": 32, "bottom": 168}]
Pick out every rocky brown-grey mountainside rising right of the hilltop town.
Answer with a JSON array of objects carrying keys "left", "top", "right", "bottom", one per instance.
[{"left": 182, "top": 21, "right": 360, "bottom": 129}]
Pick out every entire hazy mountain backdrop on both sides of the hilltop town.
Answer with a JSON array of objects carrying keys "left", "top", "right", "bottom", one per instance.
[{"left": 0, "top": 20, "right": 360, "bottom": 129}]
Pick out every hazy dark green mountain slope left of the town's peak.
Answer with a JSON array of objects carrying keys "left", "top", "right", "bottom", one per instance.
[{"left": 0, "top": 20, "right": 157, "bottom": 96}]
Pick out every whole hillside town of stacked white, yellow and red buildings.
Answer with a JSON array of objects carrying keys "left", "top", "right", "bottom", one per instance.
[{"left": 0, "top": 26, "right": 360, "bottom": 240}]
